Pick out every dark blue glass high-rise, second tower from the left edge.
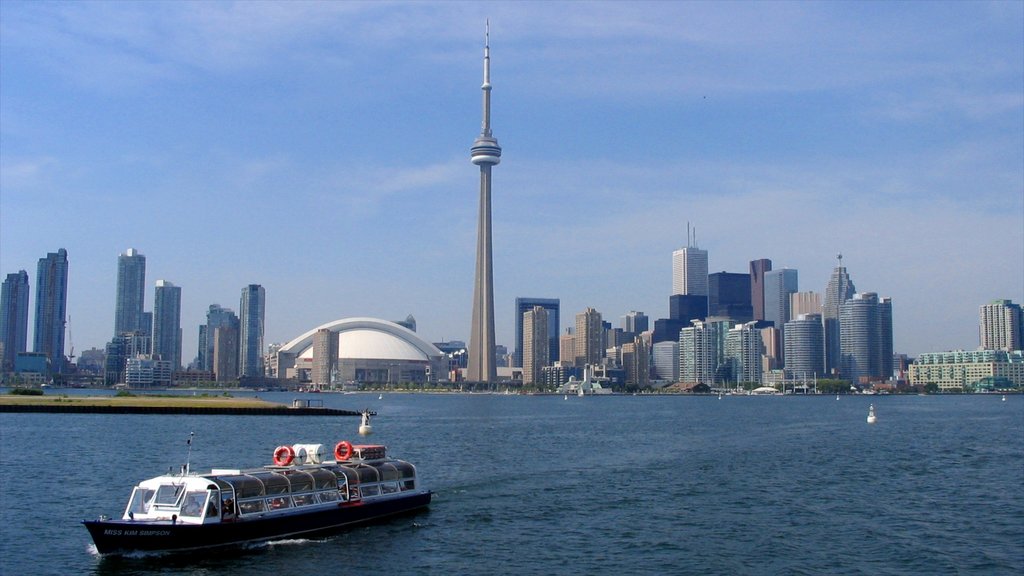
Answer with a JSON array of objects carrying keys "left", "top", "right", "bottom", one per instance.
[{"left": 32, "top": 248, "right": 68, "bottom": 373}]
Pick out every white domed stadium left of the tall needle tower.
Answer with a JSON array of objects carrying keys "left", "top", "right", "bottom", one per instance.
[{"left": 278, "top": 318, "right": 447, "bottom": 385}]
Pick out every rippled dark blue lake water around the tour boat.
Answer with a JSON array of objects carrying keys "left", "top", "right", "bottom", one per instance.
[{"left": 0, "top": 393, "right": 1024, "bottom": 575}]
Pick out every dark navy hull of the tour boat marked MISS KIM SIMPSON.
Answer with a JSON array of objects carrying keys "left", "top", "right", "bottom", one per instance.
[{"left": 82, "top": 491, "right": 431, "bottom": 554}]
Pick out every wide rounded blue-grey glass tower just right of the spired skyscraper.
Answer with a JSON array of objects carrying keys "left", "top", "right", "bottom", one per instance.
[{"left": 840, "top": 292, "right": 893, "bottom": 383}]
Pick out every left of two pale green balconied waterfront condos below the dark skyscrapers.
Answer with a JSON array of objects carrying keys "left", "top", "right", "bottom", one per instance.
[{"left": 679, "top": 318, "right": 729, "bottom": 385}]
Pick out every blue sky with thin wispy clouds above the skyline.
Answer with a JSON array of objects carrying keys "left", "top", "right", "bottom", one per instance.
[{"left": 0, "top": 1, "right": 1024, "bottom": 360}]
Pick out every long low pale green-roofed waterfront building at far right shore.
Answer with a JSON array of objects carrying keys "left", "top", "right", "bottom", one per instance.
[{"left": 909, "top": 349, "right": 1024, "bottom": 392}]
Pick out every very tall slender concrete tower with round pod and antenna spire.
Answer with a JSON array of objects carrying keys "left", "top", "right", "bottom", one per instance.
[{"left": 466, "top": 22, "right": 502, "bottom": 382}]
